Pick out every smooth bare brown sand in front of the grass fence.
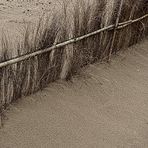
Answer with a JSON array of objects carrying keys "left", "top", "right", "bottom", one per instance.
[{"left": 0, "top": 40, "right": 148, "bottom": 148}]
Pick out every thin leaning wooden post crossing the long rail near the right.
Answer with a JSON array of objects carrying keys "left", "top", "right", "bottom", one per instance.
[{"left": 108, "top": 0, "right": 124, "bottom": 62}]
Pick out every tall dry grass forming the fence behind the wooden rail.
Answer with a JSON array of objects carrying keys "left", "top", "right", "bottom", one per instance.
[{"left": 0, "top": 0, "right": 148, "bottom": 110}]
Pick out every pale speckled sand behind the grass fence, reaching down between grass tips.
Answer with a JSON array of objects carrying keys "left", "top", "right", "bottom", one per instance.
[{"left": 0, "top": 0, "right": 56, "bottom": 47}]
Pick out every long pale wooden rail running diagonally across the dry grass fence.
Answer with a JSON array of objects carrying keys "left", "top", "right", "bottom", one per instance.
[{"left": 0, "top": 14, "right": 148, "bottom": 68}]
